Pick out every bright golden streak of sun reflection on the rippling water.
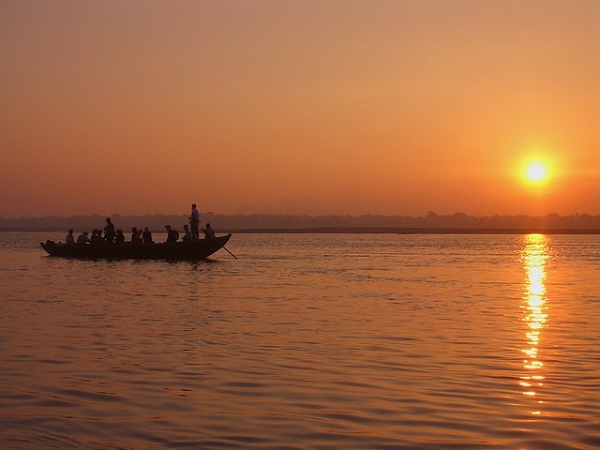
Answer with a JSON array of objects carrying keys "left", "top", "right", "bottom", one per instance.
[{"left": 520, "top": 234, "right": 549, "bottom": 415}]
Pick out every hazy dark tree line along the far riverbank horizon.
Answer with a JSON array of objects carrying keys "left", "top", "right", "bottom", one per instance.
[{"left": 0, "top": 211, "right": 600, "bottom": 232}]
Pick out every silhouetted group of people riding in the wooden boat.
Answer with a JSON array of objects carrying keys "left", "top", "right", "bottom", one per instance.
[{"left": 65, "top": 203, "right": 215, "bottom": 245}]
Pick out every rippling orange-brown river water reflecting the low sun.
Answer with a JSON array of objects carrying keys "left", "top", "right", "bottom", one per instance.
[{"left": 0, "top": 232, "right": 600, "bottom": 450}]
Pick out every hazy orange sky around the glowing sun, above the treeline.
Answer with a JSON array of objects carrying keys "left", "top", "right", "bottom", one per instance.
[{"left": 0, "top": 0, "right": 600, "bottom": 217}]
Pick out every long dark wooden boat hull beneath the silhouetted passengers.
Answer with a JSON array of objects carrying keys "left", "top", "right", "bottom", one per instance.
[{"left": 40, "top": 233, "right": 231, "bottom": 260}]
